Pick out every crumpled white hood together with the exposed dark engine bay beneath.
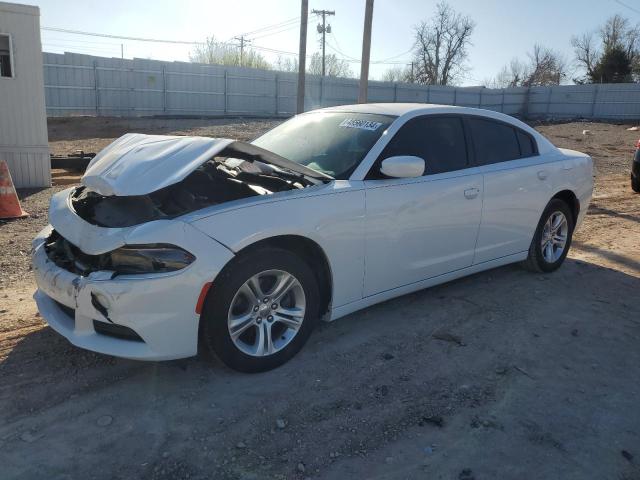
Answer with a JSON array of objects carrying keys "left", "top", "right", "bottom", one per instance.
[{"left": 71, "top": 134, "right": 330, "bottom": 228}]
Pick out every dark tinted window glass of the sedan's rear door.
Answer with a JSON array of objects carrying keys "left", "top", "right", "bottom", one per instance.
[{"left": 469, "top": 118, "right": 520, "bottom": 165}]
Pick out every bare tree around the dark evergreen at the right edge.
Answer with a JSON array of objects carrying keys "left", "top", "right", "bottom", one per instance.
[{"left": 571, "top": 15, "right": 640, "bottom": 83}]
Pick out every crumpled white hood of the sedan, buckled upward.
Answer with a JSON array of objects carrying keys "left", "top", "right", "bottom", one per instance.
[{"left": 80, "top": 133, "right": 234, "bottom": 196}]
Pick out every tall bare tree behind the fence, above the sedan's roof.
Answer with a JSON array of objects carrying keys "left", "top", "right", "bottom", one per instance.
[{"left": 414, "top": 2, "right": 475, "bottom": 85}]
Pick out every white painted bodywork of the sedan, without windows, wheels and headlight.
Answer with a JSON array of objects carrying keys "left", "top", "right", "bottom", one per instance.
[{"left": 33, "top": 104, "right": 593, "bottom": 360}]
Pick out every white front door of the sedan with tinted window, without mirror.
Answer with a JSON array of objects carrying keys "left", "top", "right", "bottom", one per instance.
[{"left": 364, "top": 115, "right": 482, "bottom": 296}]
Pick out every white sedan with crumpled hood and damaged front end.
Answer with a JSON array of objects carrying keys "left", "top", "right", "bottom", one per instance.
[{"left": 33, "top": 104, "right": 593, "bottom": 372}]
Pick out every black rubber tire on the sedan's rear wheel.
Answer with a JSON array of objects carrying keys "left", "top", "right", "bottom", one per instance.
[{"left": 524, "top": 198, "right": 576, "bottom": 273}]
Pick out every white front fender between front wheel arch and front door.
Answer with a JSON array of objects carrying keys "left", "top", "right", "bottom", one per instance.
[{"left": 193, "top": 180, "right": 365, "bottom": 306}]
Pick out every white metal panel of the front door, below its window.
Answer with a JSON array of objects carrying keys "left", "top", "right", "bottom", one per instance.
[{"left": 364, "top": 168, "right": 482, "bottom": 296}]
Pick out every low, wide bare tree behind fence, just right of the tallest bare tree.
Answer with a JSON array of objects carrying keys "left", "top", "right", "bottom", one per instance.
[{"left": 490, "top": 44, "right": 566, "bottom": 88}]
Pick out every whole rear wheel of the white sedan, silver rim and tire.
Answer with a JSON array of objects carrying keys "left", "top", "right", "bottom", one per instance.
[{"left": 525, "top": 198, "right": 575, "bottom": 272}]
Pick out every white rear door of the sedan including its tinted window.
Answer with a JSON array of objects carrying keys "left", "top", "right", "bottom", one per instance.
[{"left": 465, "top": 116, "right": 559, "bottom": 264}]
